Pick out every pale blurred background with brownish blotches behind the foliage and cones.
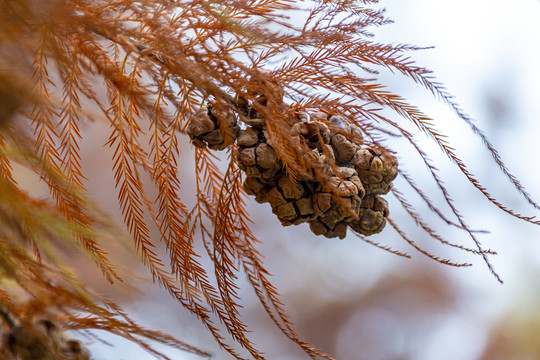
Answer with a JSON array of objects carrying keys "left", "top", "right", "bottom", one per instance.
[{"left": 16, "top": 0, "right": 540, "bottom": 360}]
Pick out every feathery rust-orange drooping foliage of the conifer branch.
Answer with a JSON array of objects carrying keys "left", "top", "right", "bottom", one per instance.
[{"left": 0, "top": 0, "right": 539, "bottom": 359}]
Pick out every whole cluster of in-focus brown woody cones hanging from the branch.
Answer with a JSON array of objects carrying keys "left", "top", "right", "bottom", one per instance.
[{"left": 188, "top": 100, "right": 398, "bottom": 238}]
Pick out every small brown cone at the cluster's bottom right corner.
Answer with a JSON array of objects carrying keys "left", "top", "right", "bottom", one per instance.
[{"left": 349, "top": 195, "right": 389, "bottom": 236}]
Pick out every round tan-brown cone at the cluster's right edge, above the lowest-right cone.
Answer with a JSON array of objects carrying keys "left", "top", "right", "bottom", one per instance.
[{"left": 353, "top": 147, "right": 398, "bottom": 195}]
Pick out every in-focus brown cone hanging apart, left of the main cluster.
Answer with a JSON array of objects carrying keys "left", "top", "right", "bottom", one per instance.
[{"left": 187, "top": 102, "right": 240, "bottom": 150}]
